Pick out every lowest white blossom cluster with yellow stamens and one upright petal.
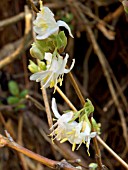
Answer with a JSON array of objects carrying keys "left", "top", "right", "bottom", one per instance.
[{"left": 50, "top": 98, "right": 96, "bottom": 153}]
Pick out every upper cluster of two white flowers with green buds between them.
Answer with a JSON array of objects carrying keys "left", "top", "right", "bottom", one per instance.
[{"left": 28, "top": 1, "right": 75, "bottom": 88}]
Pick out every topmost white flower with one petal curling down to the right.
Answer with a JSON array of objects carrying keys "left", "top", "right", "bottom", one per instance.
[{"left": 33, "top": 1, "right": 73, "bottom": 40}]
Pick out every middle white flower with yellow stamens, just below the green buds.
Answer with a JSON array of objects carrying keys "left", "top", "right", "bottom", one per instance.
[{"left": 30, "top": 53, "right": 75, "bottom": 88}]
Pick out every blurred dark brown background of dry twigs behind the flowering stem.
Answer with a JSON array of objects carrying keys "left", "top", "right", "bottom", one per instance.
[{"left": 0, "top": 0, "right": 128, "bottom": 170}]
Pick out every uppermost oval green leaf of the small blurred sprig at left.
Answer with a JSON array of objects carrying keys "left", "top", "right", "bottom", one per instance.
[{"left": 8, "top": 81, "right": 19, "bottom": 96}]
